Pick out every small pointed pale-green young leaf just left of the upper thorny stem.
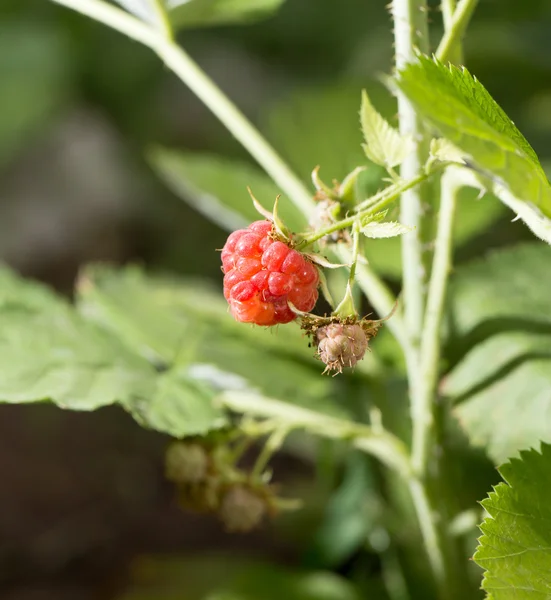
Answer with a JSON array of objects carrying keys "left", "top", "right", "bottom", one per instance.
[{"left": 360, "top": 90, "right": 413, "bottom": 169}]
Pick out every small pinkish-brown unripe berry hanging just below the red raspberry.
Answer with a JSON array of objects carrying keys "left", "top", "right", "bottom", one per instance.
[{"left": 316, "top": 323, "right": 367, "bottom": 373}]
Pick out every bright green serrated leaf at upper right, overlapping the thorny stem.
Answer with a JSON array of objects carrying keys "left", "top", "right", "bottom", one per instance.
[{"left": 396, "top": 56, "right": 551, "bottom": 232}]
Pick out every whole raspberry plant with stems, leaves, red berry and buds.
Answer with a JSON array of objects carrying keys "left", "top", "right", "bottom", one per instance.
[{"left": 7, "top": 0, "right": 551, "bottom": 600}]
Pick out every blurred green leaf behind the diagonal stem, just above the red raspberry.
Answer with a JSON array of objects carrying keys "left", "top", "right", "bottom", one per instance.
[{"left": 150, "top": 148, "right": 306, "bottom": 231}]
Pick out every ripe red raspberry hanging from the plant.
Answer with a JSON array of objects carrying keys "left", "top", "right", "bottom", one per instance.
[{"left": 222, "top": 221, "right": 319, "bottom": 325}]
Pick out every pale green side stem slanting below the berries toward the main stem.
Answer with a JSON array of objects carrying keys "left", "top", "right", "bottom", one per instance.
[{"left": 218, "top": 391, "right": 411, "bottom": 477}]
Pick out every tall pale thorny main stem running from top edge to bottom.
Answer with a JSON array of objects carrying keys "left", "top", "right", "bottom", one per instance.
[{"left": 392, "top": 0, "right": 453, "bottom": 599}]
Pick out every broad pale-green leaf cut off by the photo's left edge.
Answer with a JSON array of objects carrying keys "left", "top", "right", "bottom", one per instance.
[{"left": 0, "top": 268, "right": 156, "bottom": 410}]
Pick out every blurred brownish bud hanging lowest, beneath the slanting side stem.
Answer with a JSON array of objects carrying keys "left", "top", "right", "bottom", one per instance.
[{"left": 218, "top": 485, "right": 267, "bottom": 532}]
